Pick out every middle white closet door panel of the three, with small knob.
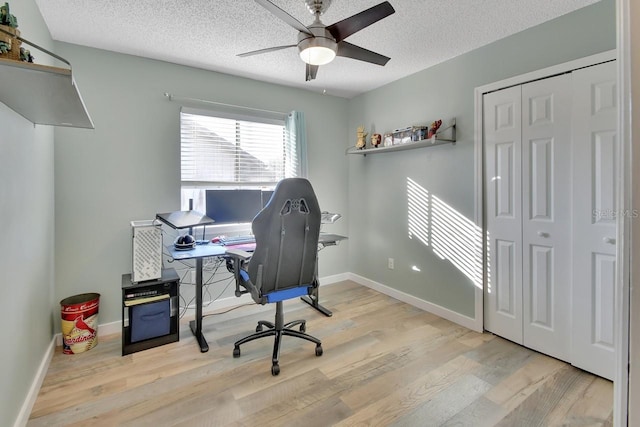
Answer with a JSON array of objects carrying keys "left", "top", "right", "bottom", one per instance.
[{"left": 522, "top": 74, "right": 571, "bottom": 360}]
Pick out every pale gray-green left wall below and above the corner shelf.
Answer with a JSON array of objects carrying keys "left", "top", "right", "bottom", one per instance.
[{"left": 0, "top": 0, "right": 59, "bottom": 426}]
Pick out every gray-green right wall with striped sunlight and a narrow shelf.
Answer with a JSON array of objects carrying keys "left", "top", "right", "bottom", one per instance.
[{"left": 345, "top": 0, "right": 616, "bottom": 317}]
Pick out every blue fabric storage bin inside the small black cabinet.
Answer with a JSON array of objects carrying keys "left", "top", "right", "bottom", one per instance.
[{"left": 131, "top": 299, "right": 171, "bottom": 342}]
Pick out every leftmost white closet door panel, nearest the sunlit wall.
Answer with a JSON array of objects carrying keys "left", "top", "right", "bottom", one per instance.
[{"left": 483, "top": 87, "right": 522, "bottom": 344}]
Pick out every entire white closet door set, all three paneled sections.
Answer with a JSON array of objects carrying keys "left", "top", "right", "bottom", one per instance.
[{"left": 483, "top": 63, "right": 616, "bottom": 378}]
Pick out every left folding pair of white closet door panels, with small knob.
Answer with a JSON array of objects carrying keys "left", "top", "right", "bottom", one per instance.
[{"left": 484, "top": 74, "right": 571, "bottom": 360}]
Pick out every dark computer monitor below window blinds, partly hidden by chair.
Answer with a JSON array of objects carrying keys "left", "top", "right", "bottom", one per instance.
[{"left": 206, "top": 189, "right": 273, "bottom": 225}]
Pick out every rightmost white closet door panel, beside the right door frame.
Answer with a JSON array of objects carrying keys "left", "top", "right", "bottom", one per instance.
[{"left": 571, "top": 58, "right": 624, "bottom": 379}]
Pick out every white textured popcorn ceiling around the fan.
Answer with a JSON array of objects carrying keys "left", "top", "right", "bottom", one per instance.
[{"left": 36, "top": 0, "right": 599, "bottom": 98}]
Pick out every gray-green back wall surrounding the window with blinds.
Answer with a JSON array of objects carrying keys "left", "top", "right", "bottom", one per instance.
[{"left": 50, "top": 43, "right": 348, "bottom": 324}]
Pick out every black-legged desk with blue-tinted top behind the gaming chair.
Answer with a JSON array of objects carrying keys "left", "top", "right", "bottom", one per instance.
[{"left": 167, "top": 233, "right": 346, "bottom": 353}]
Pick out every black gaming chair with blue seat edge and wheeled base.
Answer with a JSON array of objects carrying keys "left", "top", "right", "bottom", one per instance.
[{"left": 227, "top": 178, "right": 322, "bottom": 375}]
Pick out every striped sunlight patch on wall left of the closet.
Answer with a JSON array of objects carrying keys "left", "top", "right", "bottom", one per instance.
[{"left": 407, "top": 178, "right": 482, "bottom": 288}]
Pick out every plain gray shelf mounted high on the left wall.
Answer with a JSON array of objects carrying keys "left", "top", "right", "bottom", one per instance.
[{"left": 0, "top": 58, "right": 94, "bottom": 129}]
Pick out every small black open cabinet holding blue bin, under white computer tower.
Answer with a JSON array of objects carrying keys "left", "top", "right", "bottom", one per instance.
[{"left": 122, "top": 268, "right": 180, "bottom": 356}]
